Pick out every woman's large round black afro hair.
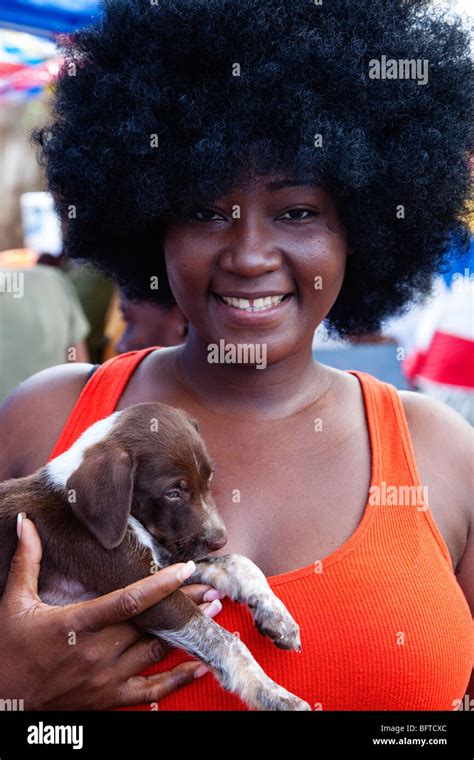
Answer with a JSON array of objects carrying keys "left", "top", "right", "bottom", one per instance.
[{"left": 32, "top": 0, "right": 472, "bottom": 336}]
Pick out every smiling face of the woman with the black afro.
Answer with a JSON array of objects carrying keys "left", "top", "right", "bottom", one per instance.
[{"left": 165, "top": 177, "right": 347, "bottom": 364}]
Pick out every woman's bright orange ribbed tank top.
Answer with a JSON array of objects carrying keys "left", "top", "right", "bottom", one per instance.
[{"left": 46, "top": 348, "right": 474, "bottom": 710}]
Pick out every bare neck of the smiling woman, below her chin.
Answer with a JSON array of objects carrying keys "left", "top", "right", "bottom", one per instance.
[{"left": 173, "top": 334, "right": 332, "bottom": 419}]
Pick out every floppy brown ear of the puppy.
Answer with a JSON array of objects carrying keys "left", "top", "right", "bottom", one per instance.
[{"left": 67, "top": 443, "right": 135, "bottom": 549}]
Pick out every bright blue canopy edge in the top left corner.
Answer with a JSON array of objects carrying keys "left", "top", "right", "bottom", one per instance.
[{"left": 0, "top": 0, "right": 101, "bottom": 37}]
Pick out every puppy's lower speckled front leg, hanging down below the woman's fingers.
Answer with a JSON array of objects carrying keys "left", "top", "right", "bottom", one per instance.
[{"left": 134, "top": 591, "right": 311, "bottom": 711}]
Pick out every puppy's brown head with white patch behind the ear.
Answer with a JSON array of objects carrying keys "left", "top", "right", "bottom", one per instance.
[{"left": 46, "top": 403, "right": 227, "bottom": 561}]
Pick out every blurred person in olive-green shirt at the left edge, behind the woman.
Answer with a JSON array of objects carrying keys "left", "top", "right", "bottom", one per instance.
[{"left": 0, "top": 248, "right": 89, "bottom": 402}]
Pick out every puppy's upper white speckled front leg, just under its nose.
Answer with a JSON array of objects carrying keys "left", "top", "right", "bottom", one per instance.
[{"left": 181, "top": 554, "right": 301, "bottom": 652}]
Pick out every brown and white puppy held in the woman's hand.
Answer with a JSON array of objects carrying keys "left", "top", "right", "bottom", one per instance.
[{"left": 0, "top": 403, "right": 310, "bottom": 710}]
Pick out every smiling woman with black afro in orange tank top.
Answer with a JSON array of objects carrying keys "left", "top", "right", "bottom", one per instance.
[{"left": 1, "top": 0, "right": 474, "bottom": 710}]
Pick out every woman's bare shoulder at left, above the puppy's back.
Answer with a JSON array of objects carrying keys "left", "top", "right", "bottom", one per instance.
[{"left": 0, "top": 363, "right": 92, "bottom": 481}]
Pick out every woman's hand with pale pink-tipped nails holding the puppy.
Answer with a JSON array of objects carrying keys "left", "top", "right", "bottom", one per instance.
[{"left": 0, "top": 519, "right": 222, "bottom": 710}]
